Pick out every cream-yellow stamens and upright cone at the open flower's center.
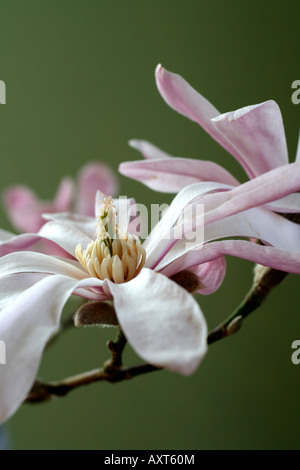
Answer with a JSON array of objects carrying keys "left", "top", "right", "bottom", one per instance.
[{"left": 75, "top": 197, "right": 146, "bottom": 284}]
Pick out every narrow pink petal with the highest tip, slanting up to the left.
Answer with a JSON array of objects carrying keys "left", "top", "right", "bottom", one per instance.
[{"left": 155, "top": 64, "right": 249, "bottom": 174}]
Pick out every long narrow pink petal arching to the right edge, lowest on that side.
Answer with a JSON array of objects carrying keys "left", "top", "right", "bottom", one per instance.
[{"left": 160, "top": 240, "right": 300, "bottom": 276}]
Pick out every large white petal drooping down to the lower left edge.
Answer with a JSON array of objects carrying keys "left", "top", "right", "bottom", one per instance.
[{"left": 0, "top": 275, "right": 107, "bottom": 423}]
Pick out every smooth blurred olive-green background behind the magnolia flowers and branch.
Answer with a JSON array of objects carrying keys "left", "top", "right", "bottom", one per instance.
[{"left": 0, "top": 0, "right": 300, "bottom": 450}]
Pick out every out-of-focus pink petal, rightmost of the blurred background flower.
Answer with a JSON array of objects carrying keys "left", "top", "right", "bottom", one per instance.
[{"left": 76, "top": 163, "right": 118, "bottom": 216}]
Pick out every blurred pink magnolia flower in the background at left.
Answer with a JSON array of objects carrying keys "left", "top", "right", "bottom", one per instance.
[{"left": 3, "top": 162, "right": 117, "bottom": 232}]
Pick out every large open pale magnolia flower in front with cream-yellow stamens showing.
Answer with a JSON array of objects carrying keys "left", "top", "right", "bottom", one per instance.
[{"left": 0, "top": 164, "right": 300, "bottom": 422}]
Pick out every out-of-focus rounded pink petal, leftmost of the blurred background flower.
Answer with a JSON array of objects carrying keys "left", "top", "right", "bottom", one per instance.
[{"left": 3, "top": 186, "right": 52, "bottom": 232}]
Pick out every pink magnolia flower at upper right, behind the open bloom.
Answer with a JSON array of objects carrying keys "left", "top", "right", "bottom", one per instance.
[{"left": 119, "top": 65, "right": 300, "bottom": 212}]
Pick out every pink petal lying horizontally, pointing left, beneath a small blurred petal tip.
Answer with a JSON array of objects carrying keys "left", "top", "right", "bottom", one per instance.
[{"left": 119, "top": 157, "right": 239, "bottom": 193}]
